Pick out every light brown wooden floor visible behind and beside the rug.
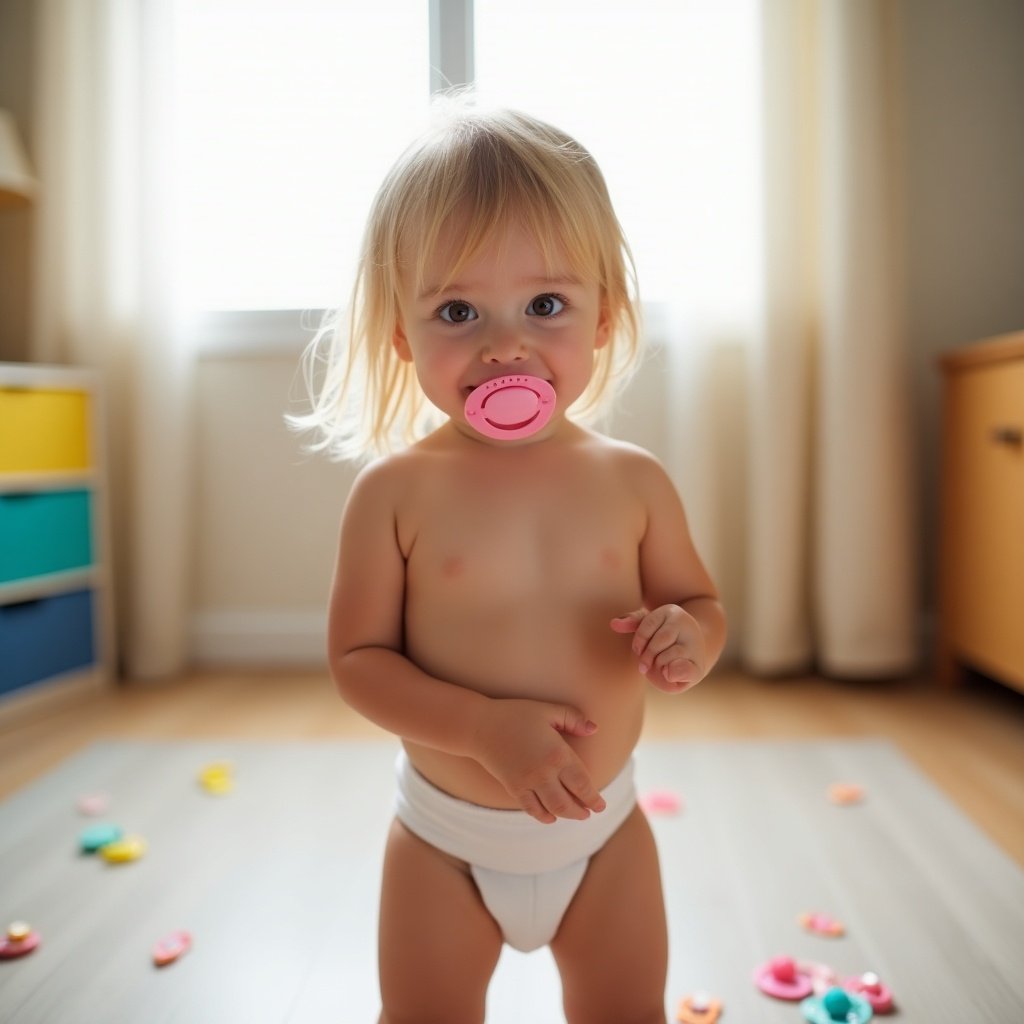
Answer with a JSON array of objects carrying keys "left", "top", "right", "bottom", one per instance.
[{"left": 0, "top": 672, "right": 1024, "bottom": 864}]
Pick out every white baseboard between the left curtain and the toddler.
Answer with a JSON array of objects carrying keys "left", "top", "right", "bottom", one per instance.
[{"left": 190, "top": 609, "right": 327, "bottom": 668}]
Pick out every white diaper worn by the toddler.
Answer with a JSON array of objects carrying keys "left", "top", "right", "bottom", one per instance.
[{"left": 395, "top": 751, "right": 636, "bottom": 952}]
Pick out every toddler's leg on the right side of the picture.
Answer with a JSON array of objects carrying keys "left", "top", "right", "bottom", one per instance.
[{"left": 551, "top": 807, "right": 669, "bottom": 1024}]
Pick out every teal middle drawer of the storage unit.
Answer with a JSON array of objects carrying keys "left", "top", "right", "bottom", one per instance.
[{"left": 0, "top": 490, "right": 92, "bottom": 584}]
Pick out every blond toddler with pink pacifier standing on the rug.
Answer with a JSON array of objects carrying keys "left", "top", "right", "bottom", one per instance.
[{"left": 304, "top": 101, "right": 725, "bottom": 1024}]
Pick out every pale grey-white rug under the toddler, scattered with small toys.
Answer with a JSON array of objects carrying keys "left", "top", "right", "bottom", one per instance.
[{"left": 0, "top": 740, "right": 1024, "bottom": 1024}]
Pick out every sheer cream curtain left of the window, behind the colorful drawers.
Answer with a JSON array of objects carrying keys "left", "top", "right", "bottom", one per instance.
[{"left": 32, "top": 0, "right": 193, "bottom": 678}]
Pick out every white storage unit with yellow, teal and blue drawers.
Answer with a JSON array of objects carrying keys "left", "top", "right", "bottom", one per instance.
[{"left": 0, "top": 364, "right": 112, "bottom": 706}]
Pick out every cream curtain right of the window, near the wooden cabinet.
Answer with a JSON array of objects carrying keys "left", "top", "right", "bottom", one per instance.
[{"left": 686, "top": 0, "right": 918, "bottom": 678}]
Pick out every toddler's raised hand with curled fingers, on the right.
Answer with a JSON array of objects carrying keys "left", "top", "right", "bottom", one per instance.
[{"left": 610, "top": 604, "right": 708, "bottom": 693}]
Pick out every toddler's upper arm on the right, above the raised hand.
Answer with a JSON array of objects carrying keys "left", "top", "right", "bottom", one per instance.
[{"left": 630, "top": 453, "right": 718, "bottom": 608}]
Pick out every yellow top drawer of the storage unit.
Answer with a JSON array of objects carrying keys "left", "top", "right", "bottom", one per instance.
[{"left": 0, "top": 386, "right": 92, "bottom": 473}]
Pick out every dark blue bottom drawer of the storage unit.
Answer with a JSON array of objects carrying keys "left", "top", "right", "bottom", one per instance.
[{"left": 0, "top": 590, "right": 96, "bottom": 693}]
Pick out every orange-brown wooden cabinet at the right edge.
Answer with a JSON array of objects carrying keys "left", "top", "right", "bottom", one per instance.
[{"left": 938, "top": 331, "right": 1024, "bottom": 691}]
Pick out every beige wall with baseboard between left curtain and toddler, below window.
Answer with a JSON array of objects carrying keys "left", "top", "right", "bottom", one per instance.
[{"left": 193, "top": 352, "right": 353, "bottom": 663}]
